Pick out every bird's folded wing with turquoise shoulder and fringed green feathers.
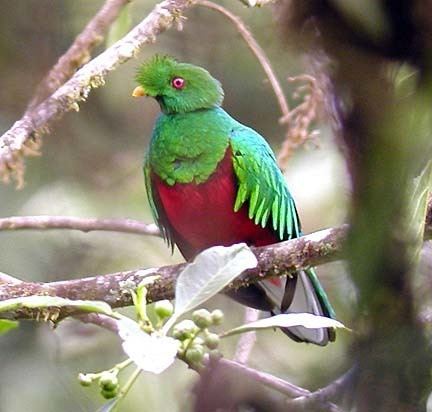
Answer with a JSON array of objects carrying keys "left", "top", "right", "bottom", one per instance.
[{"left": 231, "top": 125, "right": 301, "bottom": 240}]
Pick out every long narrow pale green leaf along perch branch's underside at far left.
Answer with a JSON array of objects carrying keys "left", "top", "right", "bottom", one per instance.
[{"left": 0, "top": 296, "right": 114, "bottom": 316}]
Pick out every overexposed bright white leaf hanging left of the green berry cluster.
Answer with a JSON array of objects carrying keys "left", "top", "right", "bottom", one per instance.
[{"left": 117, "top": 318, "right": 180, "bottom": 374}]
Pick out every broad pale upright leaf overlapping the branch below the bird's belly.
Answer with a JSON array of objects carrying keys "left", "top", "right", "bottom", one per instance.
[{"left": 162, "top": 243, "right": 258, "bottom": 333}]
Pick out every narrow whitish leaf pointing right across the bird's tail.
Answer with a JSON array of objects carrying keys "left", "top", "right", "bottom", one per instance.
[{"left": 221, "top": 313, "right": 348, "bottom": 338}]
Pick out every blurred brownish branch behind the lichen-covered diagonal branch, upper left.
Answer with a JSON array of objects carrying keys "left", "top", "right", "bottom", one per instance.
[{"left": 26, "top": 0, "right": 130, "bottom": 114}]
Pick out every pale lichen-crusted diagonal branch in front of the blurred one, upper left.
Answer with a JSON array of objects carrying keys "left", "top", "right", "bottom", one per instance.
[{"left": 0, "top": 0, "right": 191, "bottom": 186}]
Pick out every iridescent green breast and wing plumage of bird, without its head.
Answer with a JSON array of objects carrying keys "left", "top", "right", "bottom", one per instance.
[{"left": 146, "top": 108, "right": 300, "bottom": 245}]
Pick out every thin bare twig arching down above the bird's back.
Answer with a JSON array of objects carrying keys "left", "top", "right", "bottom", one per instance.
[{"left": 194, "top": 0, "right": 289, "bottom": 119}]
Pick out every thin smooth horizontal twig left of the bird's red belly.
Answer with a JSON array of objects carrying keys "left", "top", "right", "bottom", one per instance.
[{"left": 0, "top": 216, "right": 160, "bottom": 236}]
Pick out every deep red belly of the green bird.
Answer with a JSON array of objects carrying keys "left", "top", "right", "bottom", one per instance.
[{"left": 153, "top": 150, "right": 279, "bottom": 260}]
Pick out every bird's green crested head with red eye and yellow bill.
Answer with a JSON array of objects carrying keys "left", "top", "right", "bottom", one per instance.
[{"left": 133, "top": 55, "right": 223, "bottom": 113}]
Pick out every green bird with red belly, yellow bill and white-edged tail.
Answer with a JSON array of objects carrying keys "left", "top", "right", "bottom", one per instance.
[{"left": 132, "top": 55, "right": 335, "bottom": 346}]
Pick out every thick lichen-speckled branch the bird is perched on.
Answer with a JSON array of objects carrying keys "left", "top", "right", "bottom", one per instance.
[{"left": 0, "top": 226, "right": 347, "bottom": 319}]
